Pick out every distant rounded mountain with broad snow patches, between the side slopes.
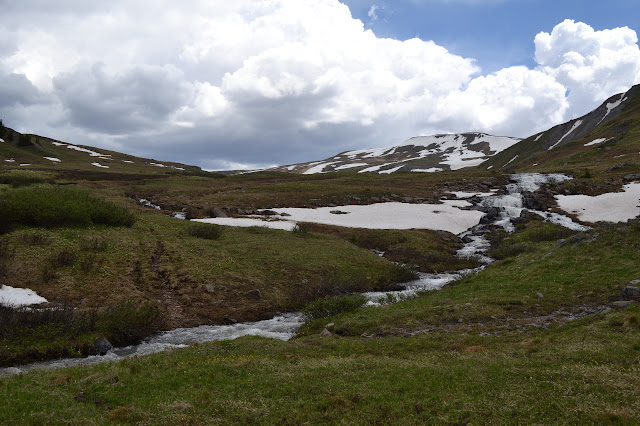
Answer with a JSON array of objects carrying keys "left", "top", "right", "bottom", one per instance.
[{"left": 269, "top": 133, "right": 520, "bottom": 174}]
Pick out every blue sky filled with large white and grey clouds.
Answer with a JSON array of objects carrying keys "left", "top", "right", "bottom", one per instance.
[{"left": 0, "top": 0, "right": 640, "bottom": 170}]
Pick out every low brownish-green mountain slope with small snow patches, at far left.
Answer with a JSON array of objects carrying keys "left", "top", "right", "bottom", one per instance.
[{"left": 0, "top": 121, "right": 206, "bottom": 174}]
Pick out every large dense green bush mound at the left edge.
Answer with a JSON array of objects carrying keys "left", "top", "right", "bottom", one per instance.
[{"left": 0, "top": 185, "right": 136, "bottom": 233}]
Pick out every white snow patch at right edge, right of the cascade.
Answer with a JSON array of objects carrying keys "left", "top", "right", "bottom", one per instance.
[{"left": 556, "top": 182, "right": 640, "bottom": 222}]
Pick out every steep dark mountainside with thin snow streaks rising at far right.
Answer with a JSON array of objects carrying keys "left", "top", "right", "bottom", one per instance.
[{"left": 480, "top": 85, "right": 640, "bottom": 171}]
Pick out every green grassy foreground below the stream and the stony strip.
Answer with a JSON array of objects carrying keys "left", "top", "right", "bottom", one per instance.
[{"left": 0, "top": 309, "right": 640, "bottom": 424}]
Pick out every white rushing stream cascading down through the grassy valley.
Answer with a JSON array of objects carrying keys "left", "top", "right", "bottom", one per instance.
[{"left": 0, "top": 173, "right": 590, "bottom": 377}]
